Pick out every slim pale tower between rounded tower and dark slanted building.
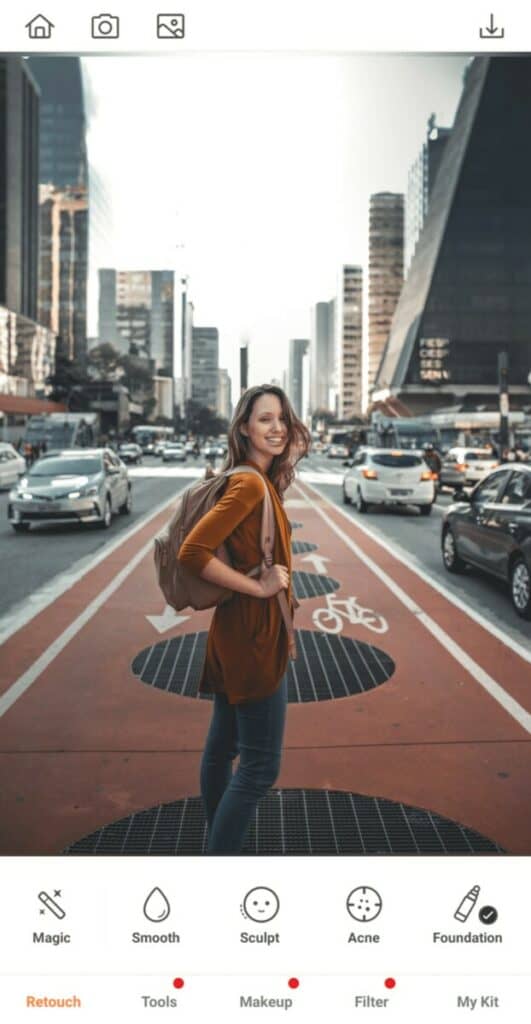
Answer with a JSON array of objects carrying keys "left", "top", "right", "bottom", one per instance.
[{"left": 404, "top": 114, "right": 451, "bottom": 273}]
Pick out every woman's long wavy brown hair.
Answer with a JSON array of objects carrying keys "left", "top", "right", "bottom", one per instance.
[{"left": 221, "top": 384, "right": 312, "bottom": 498}]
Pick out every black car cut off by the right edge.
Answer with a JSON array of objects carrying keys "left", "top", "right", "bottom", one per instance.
[{"left": 441, "top": 464, "right": 531, "bottom": 618}]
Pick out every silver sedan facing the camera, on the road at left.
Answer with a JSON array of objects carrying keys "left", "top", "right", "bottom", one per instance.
[{"left": 7, "top": 449, "right": 132, "bottom": 534}]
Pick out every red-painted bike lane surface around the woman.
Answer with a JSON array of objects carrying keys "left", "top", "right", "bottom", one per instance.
[{"left": 0, "top": 481, "right": 531, "bottom": 854}]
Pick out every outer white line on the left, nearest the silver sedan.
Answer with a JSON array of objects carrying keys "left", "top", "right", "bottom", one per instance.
[{"left": 0, "top": 494, "right": 183, "bottom": 644}]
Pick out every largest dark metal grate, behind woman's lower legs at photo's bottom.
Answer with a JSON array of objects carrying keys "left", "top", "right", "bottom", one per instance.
[{"left": 63, "top": 790, "right": 504, "bottom": 856}]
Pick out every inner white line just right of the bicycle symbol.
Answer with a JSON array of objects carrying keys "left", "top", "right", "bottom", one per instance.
[{"left": 297, "top": 487, "right": 531, "bottom": 733}]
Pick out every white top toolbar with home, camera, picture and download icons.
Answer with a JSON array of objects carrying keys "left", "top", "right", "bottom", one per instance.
[{"left": 1, "top": 0, "right": 531, "bottom": 53}]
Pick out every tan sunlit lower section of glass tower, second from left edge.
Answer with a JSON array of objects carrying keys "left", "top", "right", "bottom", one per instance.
[{"left": 38, "top": 184, "right": 88, "bottom": 364}]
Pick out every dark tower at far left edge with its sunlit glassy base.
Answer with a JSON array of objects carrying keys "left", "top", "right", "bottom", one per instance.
[{"left": 0, "top": 56, "right": 55, "bottom": 409}]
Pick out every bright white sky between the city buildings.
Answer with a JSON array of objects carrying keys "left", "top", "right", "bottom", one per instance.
[{"left": 83, "top": 54, "right": 469, "bottom": 399}]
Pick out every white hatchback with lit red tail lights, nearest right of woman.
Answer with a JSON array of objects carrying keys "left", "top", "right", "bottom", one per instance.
[{"left": 343, "top": 447, "right": 435, "bottom": 515}]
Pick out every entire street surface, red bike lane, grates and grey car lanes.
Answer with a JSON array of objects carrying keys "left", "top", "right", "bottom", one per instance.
[{"left": 0, "top": 455, "right": 531, "bottom": 854}]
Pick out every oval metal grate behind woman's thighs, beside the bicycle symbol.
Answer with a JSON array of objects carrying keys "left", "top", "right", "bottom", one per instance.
[{"left": 132, "top": 630, "right": 395, "bottom": 703}]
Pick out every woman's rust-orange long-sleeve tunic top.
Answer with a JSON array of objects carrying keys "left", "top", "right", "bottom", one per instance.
[{"left": 177, "top": 459, "right": 292, "bottom": 703}]
